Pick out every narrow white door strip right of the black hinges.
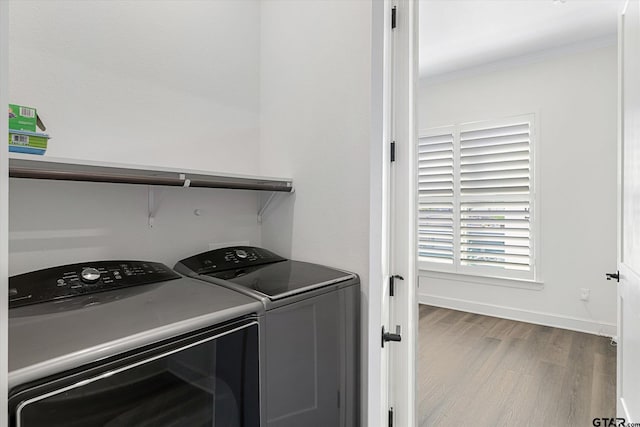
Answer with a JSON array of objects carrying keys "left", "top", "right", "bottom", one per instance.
[{"left": 384, "top": 0, "right": 418, "bottom": 427}]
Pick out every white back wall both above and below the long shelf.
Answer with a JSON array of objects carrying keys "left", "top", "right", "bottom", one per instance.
[{"left": 9, "top": 0, "right": 261, "bottom": 274}]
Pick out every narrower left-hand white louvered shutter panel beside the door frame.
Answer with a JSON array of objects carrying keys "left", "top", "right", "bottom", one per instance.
[{"left": 418, "top": 132, "right": 454, "bottom": 264}]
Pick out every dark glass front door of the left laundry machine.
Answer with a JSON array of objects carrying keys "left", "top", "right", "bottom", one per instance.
[{"left": 10, "top": 321, "right": 260, "bottom": 427}]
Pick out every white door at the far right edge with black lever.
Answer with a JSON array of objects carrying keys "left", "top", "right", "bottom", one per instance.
[{"left": 617, "top": 0, "right": 640, "bottom": 423}]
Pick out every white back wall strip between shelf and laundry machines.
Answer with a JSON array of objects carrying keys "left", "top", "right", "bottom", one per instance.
[{"left": 9, "top": 179, "right": 260, "bottom": 275}]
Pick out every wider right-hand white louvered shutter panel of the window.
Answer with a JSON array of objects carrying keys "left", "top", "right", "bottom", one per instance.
[{"left": 460, "top": 119, "right": 531, "bottom": 271}]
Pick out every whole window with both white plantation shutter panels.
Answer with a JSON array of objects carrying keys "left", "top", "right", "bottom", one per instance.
[{"left": 417, "top": 116, "right": 534, "bottom": 279}]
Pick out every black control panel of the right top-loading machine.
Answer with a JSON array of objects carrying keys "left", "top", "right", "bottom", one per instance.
[{"left": 180, "top": 246, "right": 286, "bottom": 274}]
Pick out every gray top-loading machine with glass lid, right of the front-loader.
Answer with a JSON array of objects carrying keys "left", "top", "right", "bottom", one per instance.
[{"left": 174, "top": 246, "right": 360, "bottom": 427}]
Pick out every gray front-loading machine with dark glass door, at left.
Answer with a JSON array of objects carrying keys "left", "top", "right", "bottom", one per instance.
[{"left": 8, "top": 261, "right": 264, "bottom": 427}]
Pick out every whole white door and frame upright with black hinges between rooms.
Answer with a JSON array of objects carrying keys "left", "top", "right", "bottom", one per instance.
[{"left": 367, "top": 0, "right": 418, "bottom": 427}]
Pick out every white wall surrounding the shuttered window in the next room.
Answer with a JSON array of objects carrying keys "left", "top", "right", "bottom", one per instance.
[{"left": 419, "top": 46, "right": 617, "bottom": 335}]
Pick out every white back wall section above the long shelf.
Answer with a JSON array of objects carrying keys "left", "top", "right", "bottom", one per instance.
[{"left": 9, "top": 0, "right": 260, "bottom": 173}]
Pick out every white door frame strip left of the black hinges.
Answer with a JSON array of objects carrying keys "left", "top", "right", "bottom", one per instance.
[{"left": 370, "top": 0, "right": 394, "bottom": 427}]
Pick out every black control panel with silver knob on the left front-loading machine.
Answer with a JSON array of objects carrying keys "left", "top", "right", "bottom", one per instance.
[{"left": 9, "top": 261, "right": 180, "bottom": 308}]
